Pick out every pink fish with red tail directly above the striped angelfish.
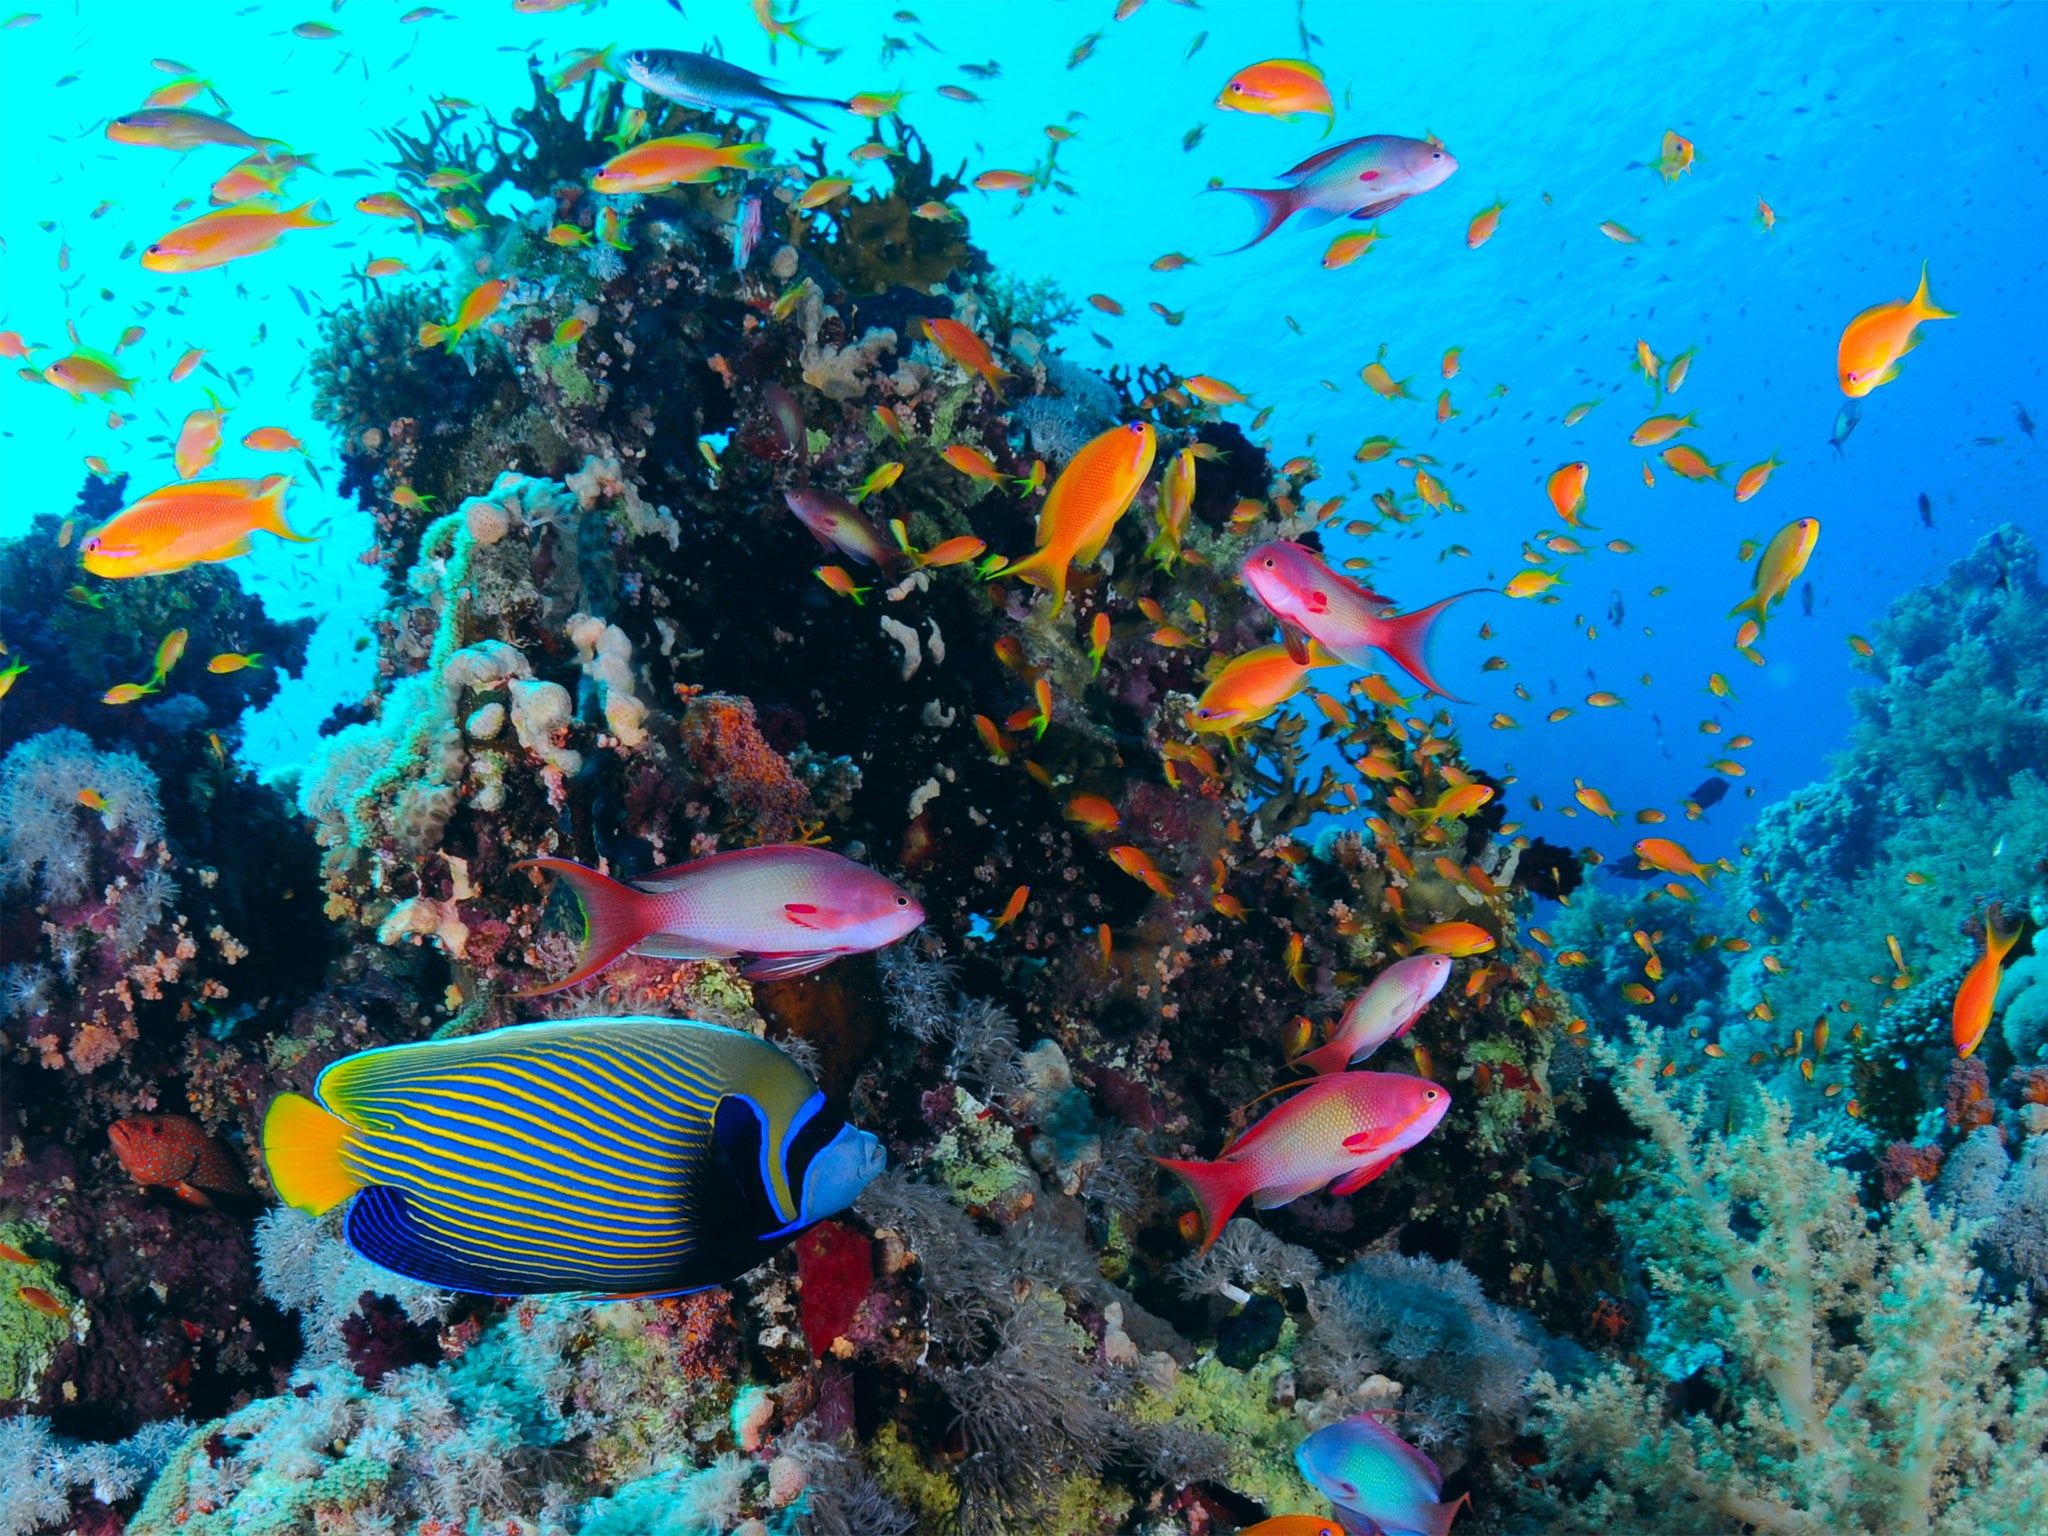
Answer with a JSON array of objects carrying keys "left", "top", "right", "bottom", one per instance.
[{"left": 514, "top": 844, "right": 924, "bottom": 995}]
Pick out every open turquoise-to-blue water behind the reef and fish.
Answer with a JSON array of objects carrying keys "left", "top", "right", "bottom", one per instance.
[{"left": 0, "top": 0, "right": 2048, "bottom": 856}]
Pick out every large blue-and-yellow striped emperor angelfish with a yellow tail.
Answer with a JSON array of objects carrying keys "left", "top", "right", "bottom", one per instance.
[{"left": 262, "top": 1018, "right": 885, "bottom": 1296}]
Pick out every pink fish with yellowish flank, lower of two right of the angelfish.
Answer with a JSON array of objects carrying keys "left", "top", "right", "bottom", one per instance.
[{"left": 1153, "top": 1071, "right": 1450, "bottom": 1251}]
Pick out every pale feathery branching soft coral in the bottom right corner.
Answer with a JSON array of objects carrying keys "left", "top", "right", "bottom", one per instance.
[{"left": 1534, "top": 1032, "right": 2048, "bottom": 1536}]
